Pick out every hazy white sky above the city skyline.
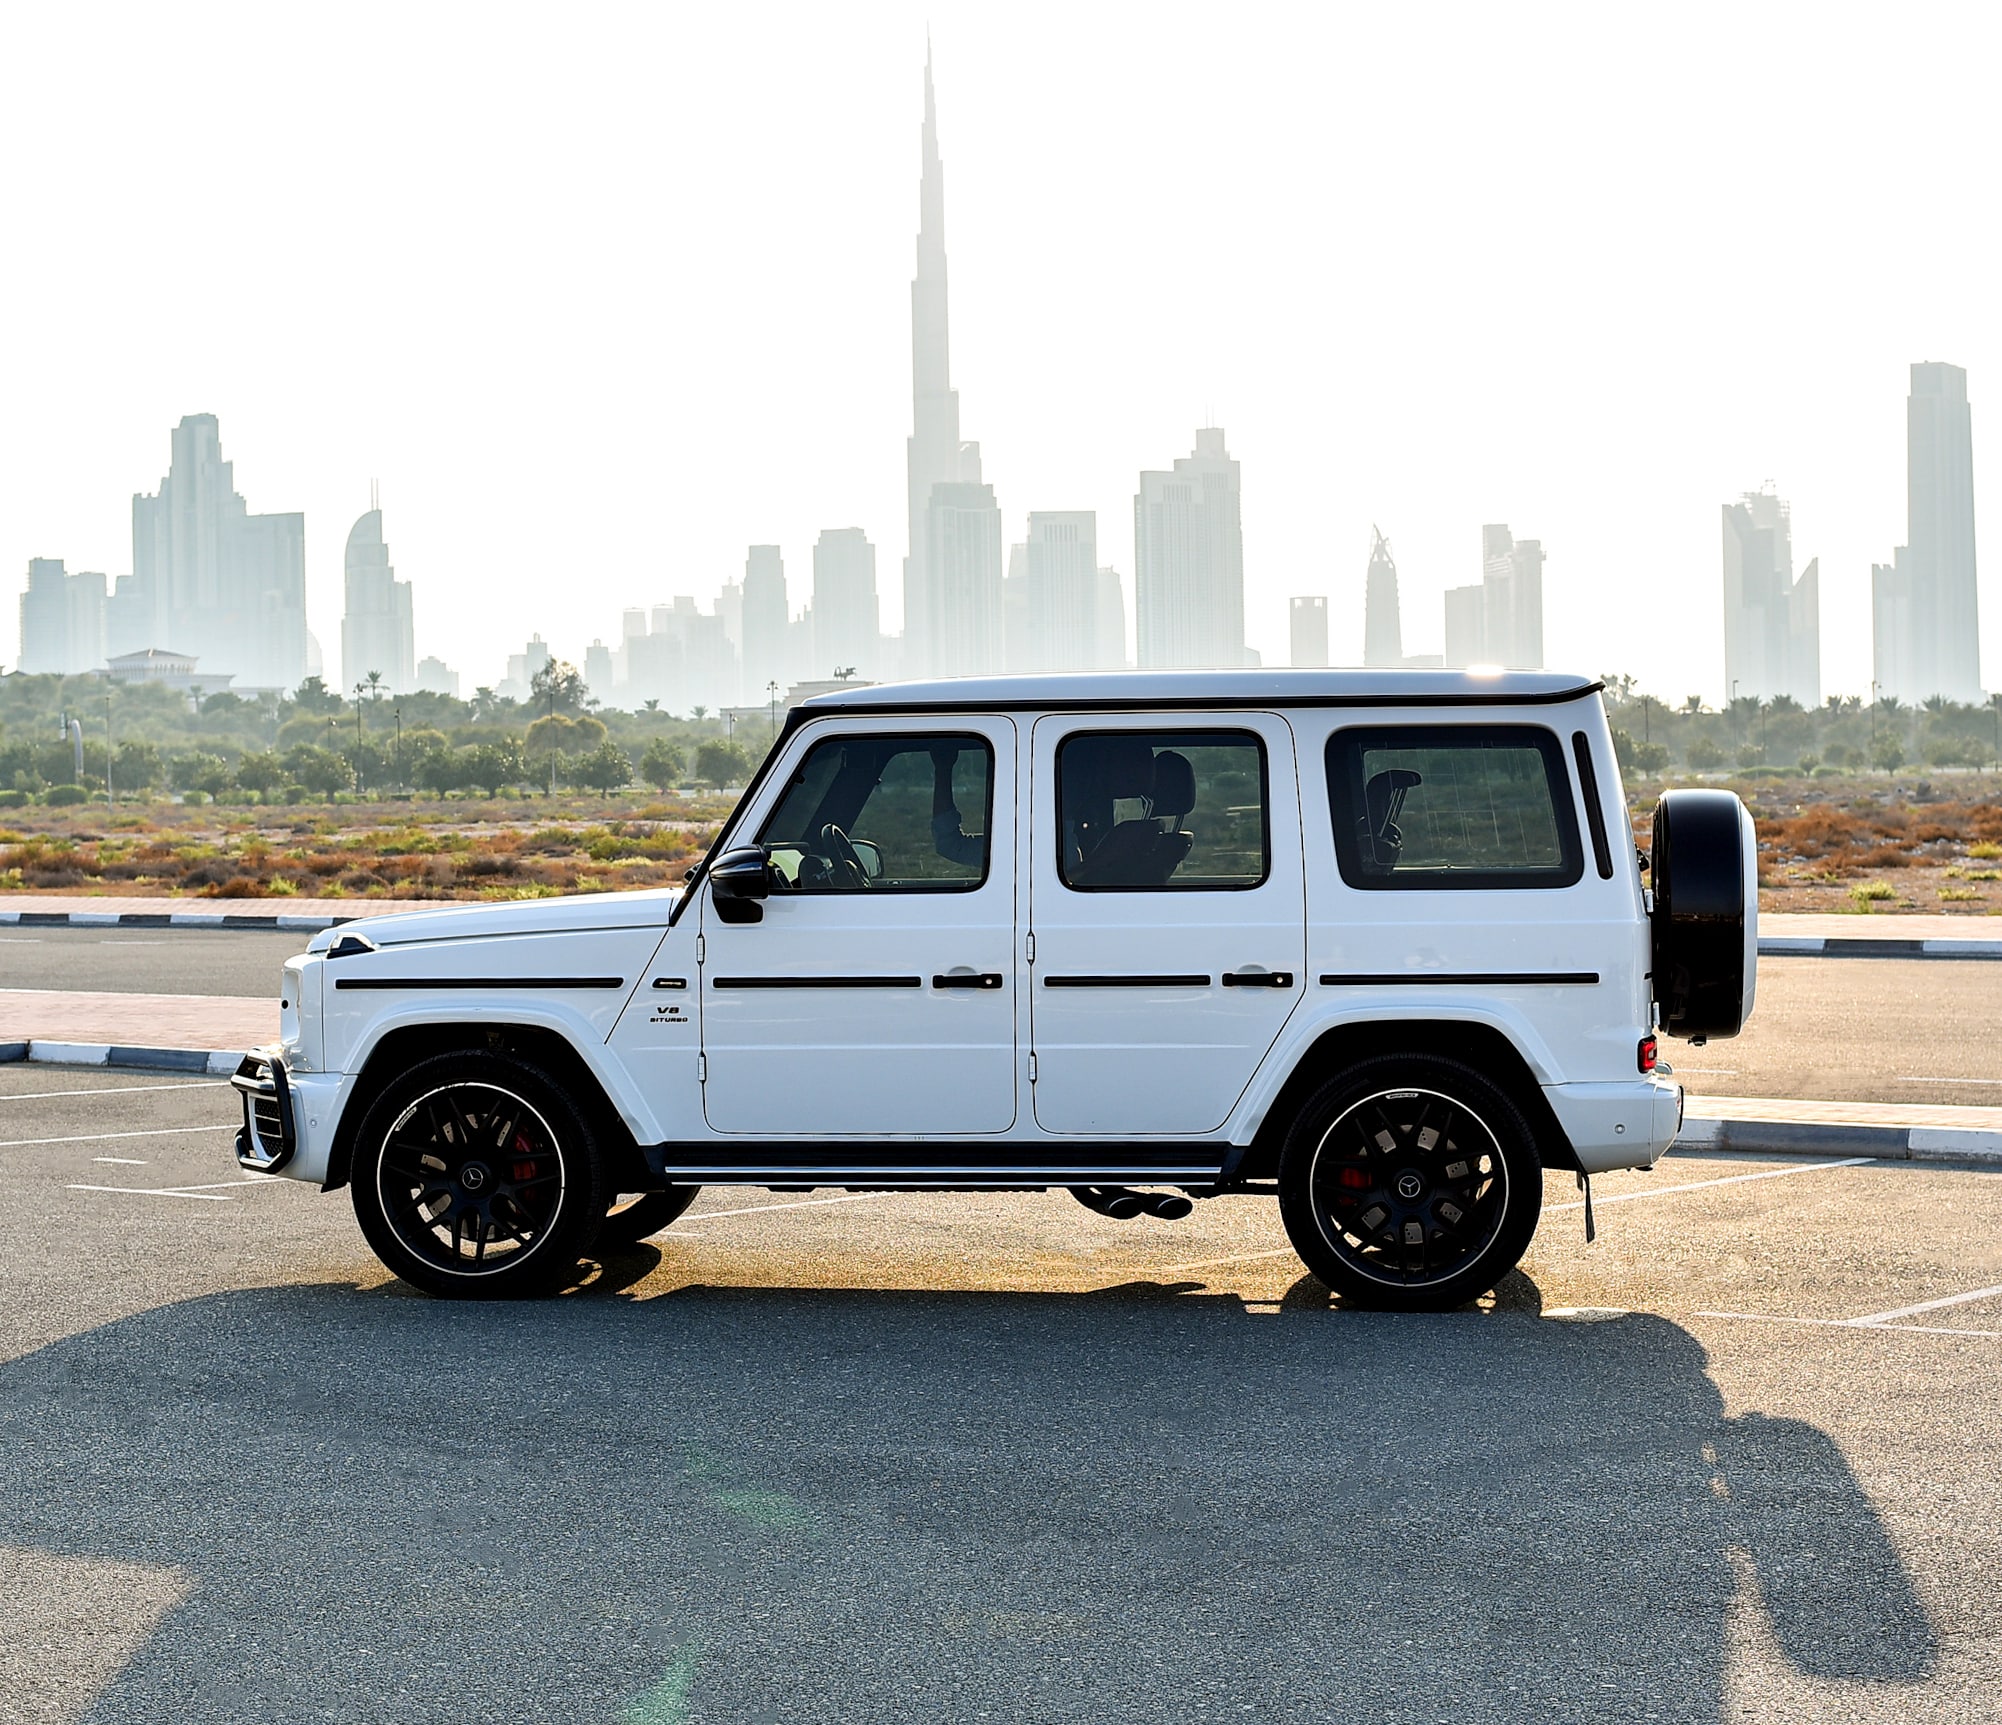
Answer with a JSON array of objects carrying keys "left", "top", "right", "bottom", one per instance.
[{"left": 0, "top": 0, "right": 2002, "bottom": 698}]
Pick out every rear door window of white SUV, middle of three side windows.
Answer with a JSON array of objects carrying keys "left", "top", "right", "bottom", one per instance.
[{"left": 1057, "top": 730, "right": 1271, "bottom": 893}]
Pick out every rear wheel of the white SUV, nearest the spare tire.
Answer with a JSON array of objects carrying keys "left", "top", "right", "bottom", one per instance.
[{"left": 1279, "top": 1055, "right": 1544, "bottom": 1311}]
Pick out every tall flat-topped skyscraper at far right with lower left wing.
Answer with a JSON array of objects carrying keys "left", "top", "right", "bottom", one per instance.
[{"left": 1870, "top": 362, "right": 1982, "bottom": 702}]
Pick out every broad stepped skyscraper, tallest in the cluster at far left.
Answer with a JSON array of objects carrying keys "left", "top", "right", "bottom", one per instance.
[{"left": 108, "top": 414, "right": 306, "bottom": 688}]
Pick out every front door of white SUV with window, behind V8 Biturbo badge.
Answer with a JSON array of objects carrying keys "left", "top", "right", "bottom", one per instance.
[{"left": 701, "top": 718, "right": 1017, "bottom": 1139}]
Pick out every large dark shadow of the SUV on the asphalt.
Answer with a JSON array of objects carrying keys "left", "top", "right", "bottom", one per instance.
[{"left": 0, "top": 1272, "right": 1938, "bottom": 1725}]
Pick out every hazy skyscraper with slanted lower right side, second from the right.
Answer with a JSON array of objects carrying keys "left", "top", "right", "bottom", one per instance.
[{"left": 1724, "top": 490, "right": 1822, "bottom": 706}]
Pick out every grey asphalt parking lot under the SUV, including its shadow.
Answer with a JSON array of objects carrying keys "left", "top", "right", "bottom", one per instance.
[{"left": 0, "top": 1067, "right": 2002, "bottom": 1725}]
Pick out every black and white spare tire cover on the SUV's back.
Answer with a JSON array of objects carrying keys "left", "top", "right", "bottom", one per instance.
[{"left": 1650, "top": 790, "right": 1758, "bottom": 1037}]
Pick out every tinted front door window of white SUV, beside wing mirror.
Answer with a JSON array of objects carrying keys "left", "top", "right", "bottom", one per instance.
[{"left": 759, "top": 734, "right": 995, "bottom": 893}]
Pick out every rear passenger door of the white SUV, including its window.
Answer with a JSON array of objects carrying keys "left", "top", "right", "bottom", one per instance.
[{"left": 1029, "top": 712, "right": 1307, "bottom": 1139}]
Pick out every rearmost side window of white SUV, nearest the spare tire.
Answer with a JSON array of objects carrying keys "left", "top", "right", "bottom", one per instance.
[{"left": 1327, "top": 724, "right": 1586, "bottom": 891}]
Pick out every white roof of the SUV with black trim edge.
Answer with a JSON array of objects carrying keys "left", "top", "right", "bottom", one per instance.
[{"left": 795, "top": 668, "right": 1602, "bottom": 714}]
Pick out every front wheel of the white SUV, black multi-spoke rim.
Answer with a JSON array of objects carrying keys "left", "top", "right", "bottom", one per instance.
[{"left": 352, "top": 1049, "right": 609, "bottom": 1299}]
